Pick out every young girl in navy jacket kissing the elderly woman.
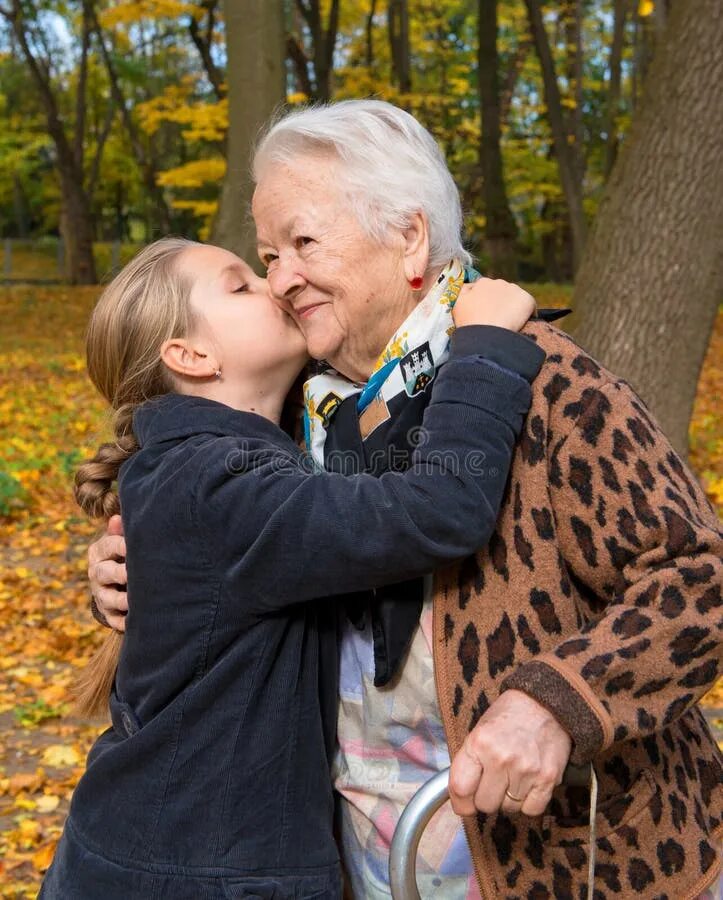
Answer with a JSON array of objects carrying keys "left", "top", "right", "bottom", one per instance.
[{"left": 40, "top": 239, "right": 543, "bottom": 900}]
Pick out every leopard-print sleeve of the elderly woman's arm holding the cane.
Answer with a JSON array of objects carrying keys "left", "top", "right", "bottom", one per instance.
[{"left": 503, "top": 382, "right": 723, "bottom": 763}]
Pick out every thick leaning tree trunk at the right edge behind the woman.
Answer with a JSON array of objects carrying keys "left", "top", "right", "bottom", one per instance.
[{"left": 571, "top": 0, "right": 723, "bottom": 453}]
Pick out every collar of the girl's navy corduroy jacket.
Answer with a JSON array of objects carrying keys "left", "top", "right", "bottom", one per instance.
[{"left": 133, "top": 394, "right": 298, "bottom": 452}]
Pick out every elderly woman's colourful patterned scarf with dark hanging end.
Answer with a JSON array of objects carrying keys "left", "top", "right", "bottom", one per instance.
[{"left": 304, "top": 260, "right": 470, "bottom": 687}]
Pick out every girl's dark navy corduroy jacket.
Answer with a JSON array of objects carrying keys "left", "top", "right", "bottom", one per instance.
[{"left": 41, "top": 327, "right": 544, "bottom": 900}]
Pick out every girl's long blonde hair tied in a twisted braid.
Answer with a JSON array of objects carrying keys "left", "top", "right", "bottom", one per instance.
[{"left": 73, "top": 238, "right": 199, "bottom": 716}]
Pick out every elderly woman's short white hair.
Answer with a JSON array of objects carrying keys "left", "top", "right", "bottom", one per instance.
[{"left": 253, "top": 100, "right": 472, "bottom": 267}]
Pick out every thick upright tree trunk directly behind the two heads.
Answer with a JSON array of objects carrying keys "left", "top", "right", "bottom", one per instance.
[{"left": 211, "top": 0, "right": 286, "bottom": 265}]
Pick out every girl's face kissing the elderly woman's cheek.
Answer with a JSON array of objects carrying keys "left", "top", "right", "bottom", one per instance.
[{"left": 179, "top": 246, "right": 308, "bottom": 383}]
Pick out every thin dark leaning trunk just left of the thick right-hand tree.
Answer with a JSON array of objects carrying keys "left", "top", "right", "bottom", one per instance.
[{"left": 525, "top": 0, "right": 587, "bottom": 268}]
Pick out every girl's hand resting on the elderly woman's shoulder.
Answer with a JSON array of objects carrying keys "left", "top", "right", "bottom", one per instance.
[{"left": 452, "top": 278, "right": 536, "bottom": 331}]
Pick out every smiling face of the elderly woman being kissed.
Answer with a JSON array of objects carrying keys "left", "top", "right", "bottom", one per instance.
[{"left": 253, "top": 157, "right": 424, "bottom": 381}]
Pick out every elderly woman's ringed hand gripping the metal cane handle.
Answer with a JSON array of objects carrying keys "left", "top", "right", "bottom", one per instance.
[{"left": 449, "top": 690, "right": 572, "bottom": 816}]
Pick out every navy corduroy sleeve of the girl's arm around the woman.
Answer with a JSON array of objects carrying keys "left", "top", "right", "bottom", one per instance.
[{"left": 202, "top": 334, "right": 544, "bottom": 614}]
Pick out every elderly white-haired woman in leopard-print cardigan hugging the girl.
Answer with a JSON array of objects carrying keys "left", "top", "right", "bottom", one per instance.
[{"left": 90, "top": 101, "right": 723, "bottom": 900}]
